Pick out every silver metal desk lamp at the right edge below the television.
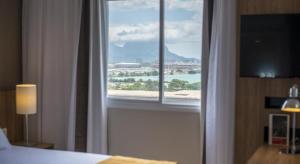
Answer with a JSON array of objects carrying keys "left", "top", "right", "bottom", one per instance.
[{"left": 281, "top": 85, "right": 300, "bottom": 154}]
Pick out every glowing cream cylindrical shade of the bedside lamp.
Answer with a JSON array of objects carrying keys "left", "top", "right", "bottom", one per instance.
[{"left": 16, "top": 84, "right": 37, "bottom": 115}]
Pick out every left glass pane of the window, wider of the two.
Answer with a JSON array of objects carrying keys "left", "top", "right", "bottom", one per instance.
[{"left": 108, "top": 0, "right": 159, "bottom": 100}]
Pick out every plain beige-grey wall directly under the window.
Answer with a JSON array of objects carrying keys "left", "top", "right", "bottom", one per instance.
[{"left": 109, "top": 109, "right": 200, "bottom": 164}]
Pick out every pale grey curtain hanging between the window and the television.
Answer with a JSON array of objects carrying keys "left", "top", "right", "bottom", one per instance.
[{"left": 206, "top": 0, "right": 236, "bottom": 164}]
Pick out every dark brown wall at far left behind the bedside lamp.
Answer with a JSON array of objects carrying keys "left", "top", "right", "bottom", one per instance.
[{"left": 0, "top": 0, "right": 23, "bottom": 141}]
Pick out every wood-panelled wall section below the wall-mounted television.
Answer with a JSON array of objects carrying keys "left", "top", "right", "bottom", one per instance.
[{"left": 235, "top": 78, "right": 300, "bottom": 164}]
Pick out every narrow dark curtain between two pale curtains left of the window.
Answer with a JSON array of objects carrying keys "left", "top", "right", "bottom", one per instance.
[{"left": 75, "top": 0, "right": 89, "bottom": 152}]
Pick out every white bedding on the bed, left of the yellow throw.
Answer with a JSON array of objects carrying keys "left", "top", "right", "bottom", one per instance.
[{"left": 0, "top": 146, "right": 110, "bottom": 164}]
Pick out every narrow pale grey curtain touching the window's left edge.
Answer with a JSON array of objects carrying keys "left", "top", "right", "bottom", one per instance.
[{"left": 87, "top": 0, "right": 107, "bottom": 154}]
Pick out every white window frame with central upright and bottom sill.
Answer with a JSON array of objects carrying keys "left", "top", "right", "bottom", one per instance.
[{"left": 105, "top": 0, "right": 204, "bottom": 113}]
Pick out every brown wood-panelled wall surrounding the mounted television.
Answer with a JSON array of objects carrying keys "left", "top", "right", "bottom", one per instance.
[{"left": 235, "top": 0, "right": 300, "bottom": 164}]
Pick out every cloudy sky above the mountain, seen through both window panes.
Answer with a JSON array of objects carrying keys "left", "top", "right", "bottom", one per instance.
[{"left": 109, "top": 0, "right": 203, "bottom": 58}]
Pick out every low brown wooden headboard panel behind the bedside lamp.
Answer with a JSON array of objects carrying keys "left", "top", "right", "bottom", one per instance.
[{"left": 0, "top": 91, "right": 23, "bottom": 142}]
